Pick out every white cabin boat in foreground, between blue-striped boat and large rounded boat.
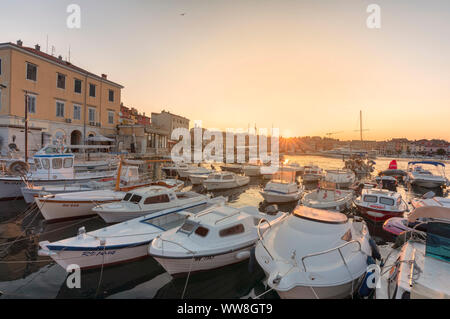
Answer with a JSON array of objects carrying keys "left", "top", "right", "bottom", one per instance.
[{"left": 149, "top": 205, "right": 287, "bottom": 276}]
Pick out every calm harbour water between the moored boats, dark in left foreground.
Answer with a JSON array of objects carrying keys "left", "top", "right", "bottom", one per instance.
[{"left": 0, "top": 156, "right": 450, "bottom": 298}]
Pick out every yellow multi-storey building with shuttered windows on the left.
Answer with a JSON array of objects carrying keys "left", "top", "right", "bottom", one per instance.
[{"left": 0, "top": 40, "right": 123, "bottom": 154}]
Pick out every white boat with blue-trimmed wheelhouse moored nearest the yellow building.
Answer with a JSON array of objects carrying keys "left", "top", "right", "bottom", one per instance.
[{"left": 0, "top": 146, "right": 115, "bottom": 200}]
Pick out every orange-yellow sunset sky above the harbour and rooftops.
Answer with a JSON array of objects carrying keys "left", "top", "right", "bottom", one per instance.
[{"left": 0, "top": 0, "right": 450, "bottom": 140}]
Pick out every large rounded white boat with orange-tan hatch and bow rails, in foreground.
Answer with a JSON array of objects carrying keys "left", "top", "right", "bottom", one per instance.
[{"left": 255, "top": 206, "right": 372, "bottom": 299}]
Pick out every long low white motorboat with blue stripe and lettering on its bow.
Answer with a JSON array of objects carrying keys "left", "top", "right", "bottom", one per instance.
[{"left": 38, "top": 197, "right": 225, "bottom": 269}]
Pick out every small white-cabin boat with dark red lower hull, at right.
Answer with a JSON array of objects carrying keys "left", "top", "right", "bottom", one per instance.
[{"left": 354, "top": 188, "right": 408, "bottom": 222}]
